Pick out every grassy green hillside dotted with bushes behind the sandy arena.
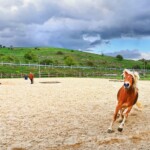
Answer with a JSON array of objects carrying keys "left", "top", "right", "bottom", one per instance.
[{"left": 0, "top": 47, "right": 150, "bottom": 78}]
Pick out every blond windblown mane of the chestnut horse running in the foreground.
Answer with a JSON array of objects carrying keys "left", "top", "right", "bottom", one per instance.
[{"left": 123, "top": 69, "right": 140, "bottom": 88}]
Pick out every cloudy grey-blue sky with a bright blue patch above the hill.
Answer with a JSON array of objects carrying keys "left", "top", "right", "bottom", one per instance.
[{"left": 0, "top": 0, "right": 150, "bottom": 60}]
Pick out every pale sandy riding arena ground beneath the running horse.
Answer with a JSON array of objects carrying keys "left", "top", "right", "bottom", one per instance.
[{"left": 0, "top": 78, "right": 150, "bottom": 150}]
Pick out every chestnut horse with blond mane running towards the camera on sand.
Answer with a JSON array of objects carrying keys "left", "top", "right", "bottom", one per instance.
[{"left": 108, "top": 69, "right": 139, "bottom": 133}]
